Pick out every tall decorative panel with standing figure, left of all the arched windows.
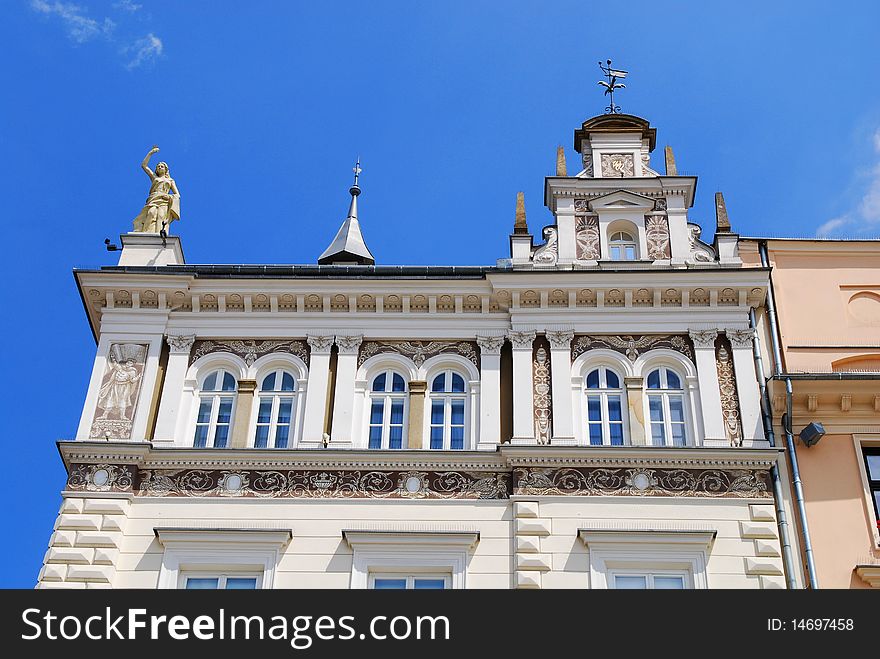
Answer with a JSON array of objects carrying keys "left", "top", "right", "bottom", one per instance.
[{"left": 89, "top": 343, "right": 148, "bottom": 439}]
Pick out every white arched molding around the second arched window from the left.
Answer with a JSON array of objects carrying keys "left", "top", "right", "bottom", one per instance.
[{"left": 247, "top": 352, "right": 309, "bottom": 448}]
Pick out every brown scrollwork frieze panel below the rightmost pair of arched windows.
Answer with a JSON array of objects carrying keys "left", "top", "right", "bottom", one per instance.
[{"left": 513, "top": 467, "right": 773, "bottom": 499}]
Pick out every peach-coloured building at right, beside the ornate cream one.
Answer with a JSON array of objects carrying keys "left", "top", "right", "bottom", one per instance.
[{"left": 740, "top": 238, "right": 880, "bottom": 588}]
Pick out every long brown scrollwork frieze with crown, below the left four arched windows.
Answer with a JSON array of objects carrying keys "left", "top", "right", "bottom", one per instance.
[{"left": 135, "top": 469, "right": 510, "bottom": 499}]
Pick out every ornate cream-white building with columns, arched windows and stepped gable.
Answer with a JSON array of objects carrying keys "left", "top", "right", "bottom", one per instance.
[{"left": 38, "top": 114, "right": 802, "bottom": 588}]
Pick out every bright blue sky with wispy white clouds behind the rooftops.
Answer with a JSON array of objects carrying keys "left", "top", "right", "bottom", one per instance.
[{"left": 0, "top": 0, "right": 880, "bottom": 588}]
